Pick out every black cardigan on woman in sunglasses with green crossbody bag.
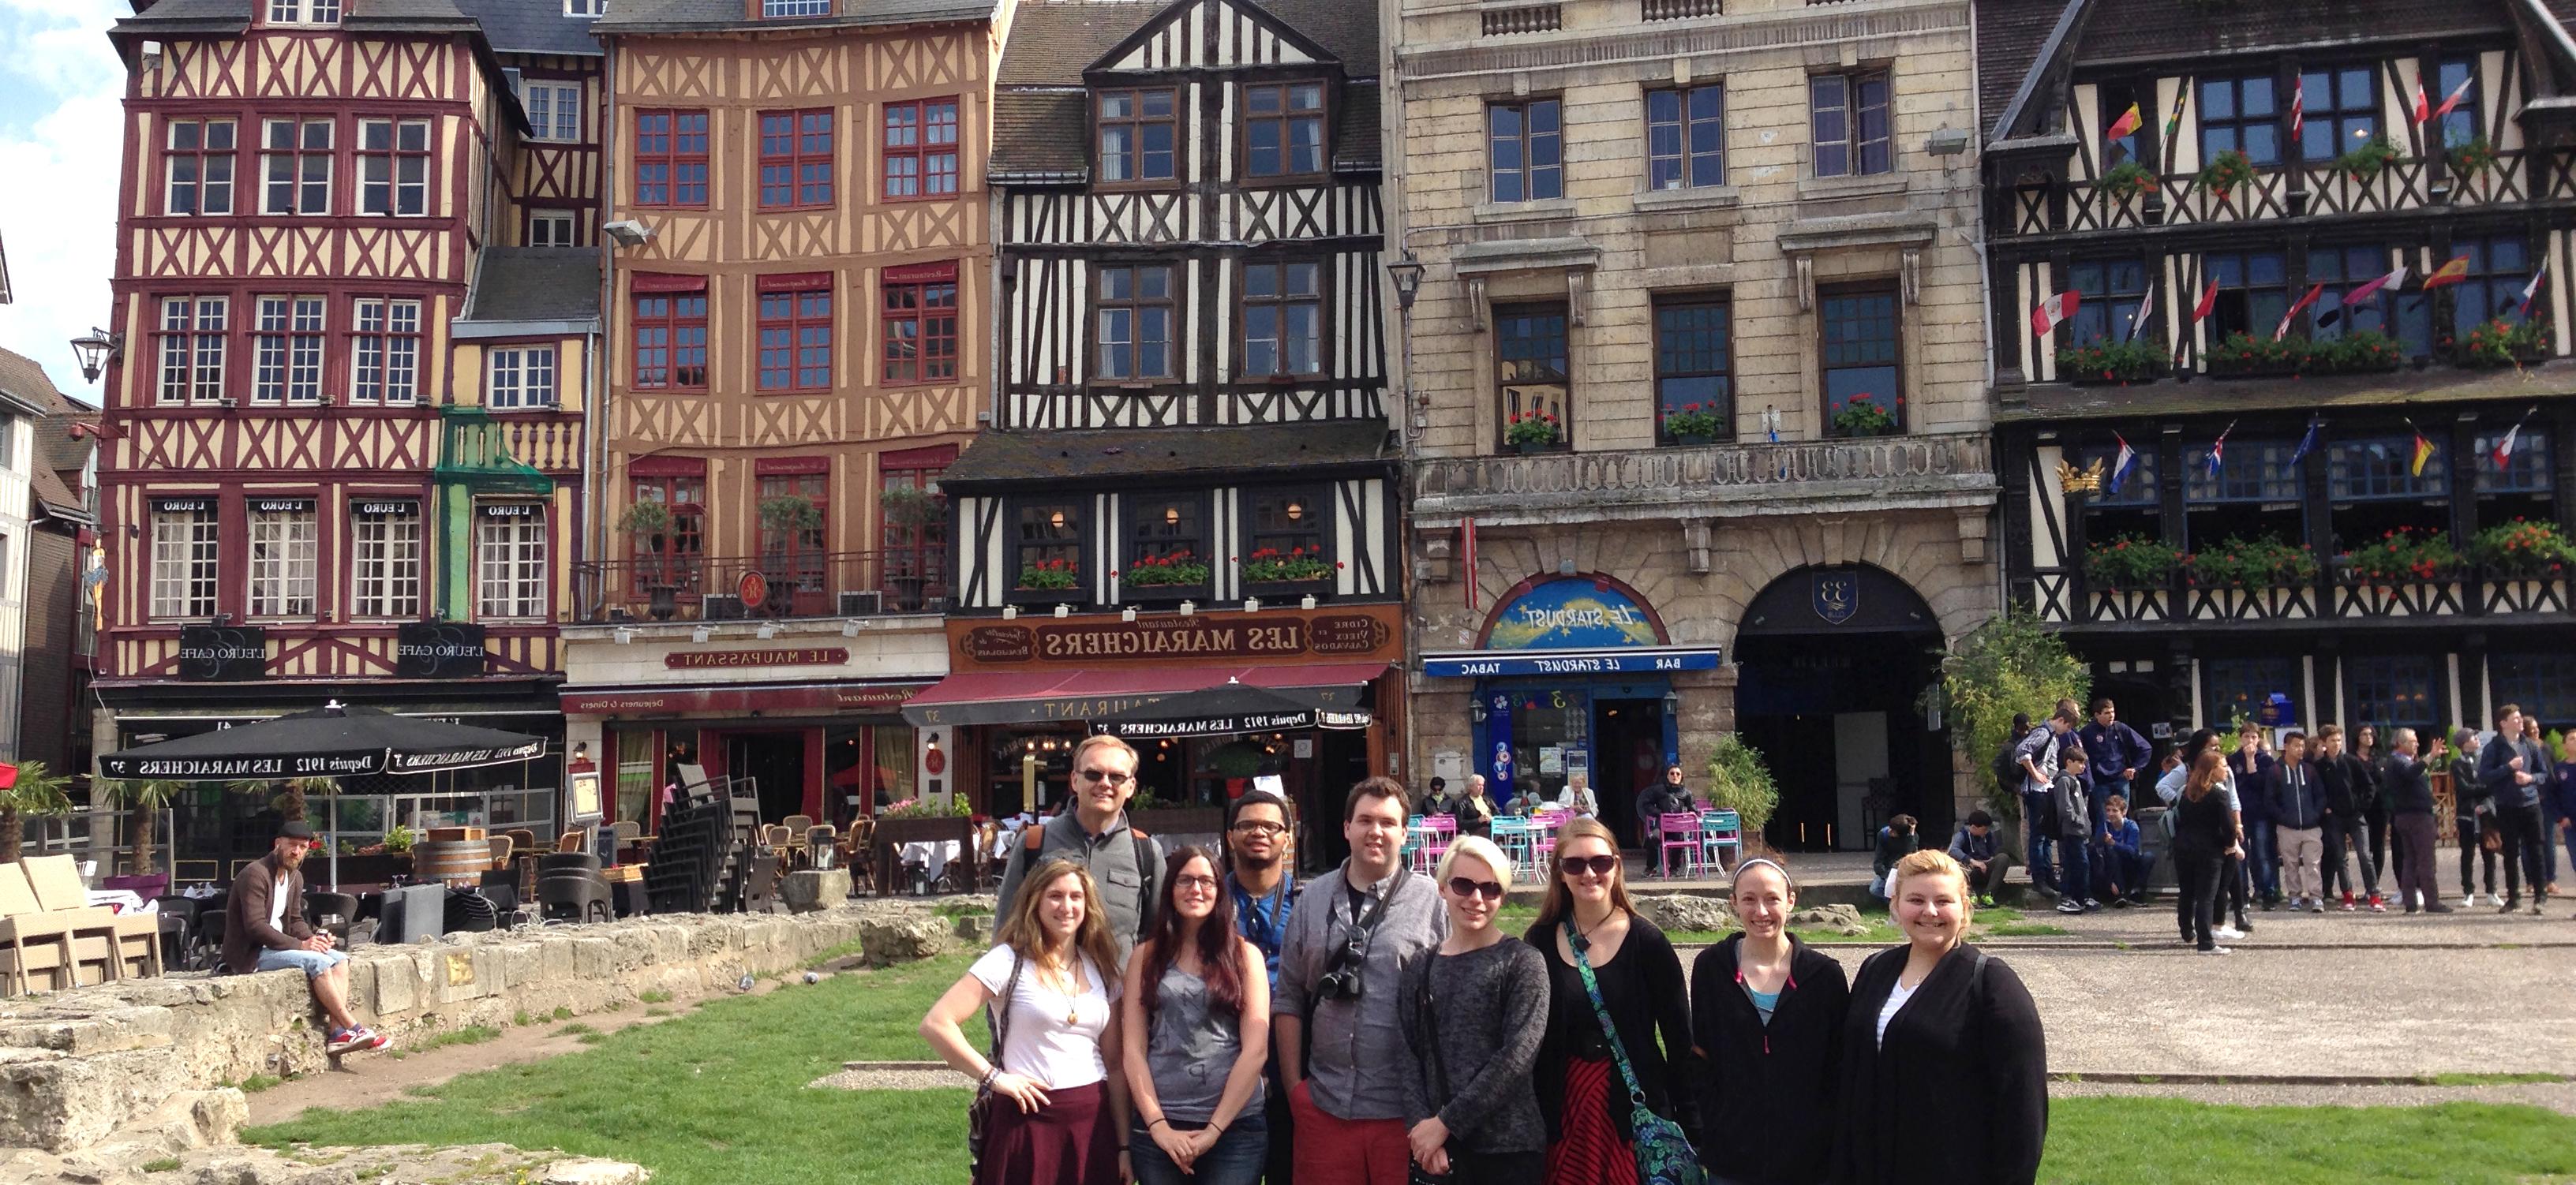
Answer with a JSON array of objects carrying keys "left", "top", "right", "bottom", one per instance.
[{"left": 1528, "top": 914, "right": 1690, "bottom": 1144}]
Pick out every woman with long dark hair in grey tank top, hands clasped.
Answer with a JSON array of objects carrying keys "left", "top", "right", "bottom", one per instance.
[{"left": 1123, "top": 847, "right": 1270, "bottom": 1185}]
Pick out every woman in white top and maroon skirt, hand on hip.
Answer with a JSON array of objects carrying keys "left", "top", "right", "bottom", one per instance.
[{"left": 923, "top": 861, "right": 1133, "bottom": 1185}]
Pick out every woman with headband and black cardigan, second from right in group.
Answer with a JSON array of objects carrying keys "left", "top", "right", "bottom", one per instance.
[{"left": 1687, "top": 858, "right": 1850, "bottom": 1185}]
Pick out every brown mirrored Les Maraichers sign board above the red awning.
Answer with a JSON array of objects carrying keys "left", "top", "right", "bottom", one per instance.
[{"left": 948, "top": 605, "right": 1402, "bottom": 667}]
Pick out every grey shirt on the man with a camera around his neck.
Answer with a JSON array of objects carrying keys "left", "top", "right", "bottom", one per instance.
[{"left": 1270, "top": 863, "right": 1447, "bottom": 1118}]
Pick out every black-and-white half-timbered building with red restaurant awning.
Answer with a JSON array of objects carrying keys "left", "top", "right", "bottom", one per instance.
[{"left": 909, "top": 0, "right": 1402, "bottom": 844}]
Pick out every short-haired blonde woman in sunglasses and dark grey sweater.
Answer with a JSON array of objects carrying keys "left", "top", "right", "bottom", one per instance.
[{"left": 1396, "top": 835, "right": 1548, "bottom": 1185}]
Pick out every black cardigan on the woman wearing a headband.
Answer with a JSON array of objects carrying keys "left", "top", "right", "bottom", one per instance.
[{"left": 1687, "top": 935, "right": 1852, "bottom": 1185}]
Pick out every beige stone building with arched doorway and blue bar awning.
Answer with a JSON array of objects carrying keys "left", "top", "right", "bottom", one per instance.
[{"left": 1386, "top": 0, "right": 1999, "bottom": 847}]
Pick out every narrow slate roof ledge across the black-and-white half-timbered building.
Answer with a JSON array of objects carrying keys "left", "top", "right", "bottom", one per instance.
[{"left": 940, "top": 420, "right": 1396, "bottom": 487}]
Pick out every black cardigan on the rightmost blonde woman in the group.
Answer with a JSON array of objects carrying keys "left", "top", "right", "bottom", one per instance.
[{"left": 1834, "top": 945, "right": 2048, "bottom": 1185}]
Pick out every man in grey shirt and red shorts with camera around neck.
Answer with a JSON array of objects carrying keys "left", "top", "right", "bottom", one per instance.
[{"left": 1270, "top": 778, "right": 1447, "bottom": 1185}]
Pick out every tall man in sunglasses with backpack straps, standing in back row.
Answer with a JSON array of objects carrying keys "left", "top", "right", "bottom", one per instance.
[{"left": 992, "top": 735, "right": 1162, "bottom": 969}]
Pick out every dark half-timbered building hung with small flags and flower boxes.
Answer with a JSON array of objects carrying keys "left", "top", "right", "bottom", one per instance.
[{"left": 1979, "top": 0, "right": 2576, "bottom": 739}]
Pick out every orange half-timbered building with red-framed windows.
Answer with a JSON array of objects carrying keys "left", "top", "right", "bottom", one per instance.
[{"left": 564, "top": 0, "right": 1002, "bottom": 822}]
